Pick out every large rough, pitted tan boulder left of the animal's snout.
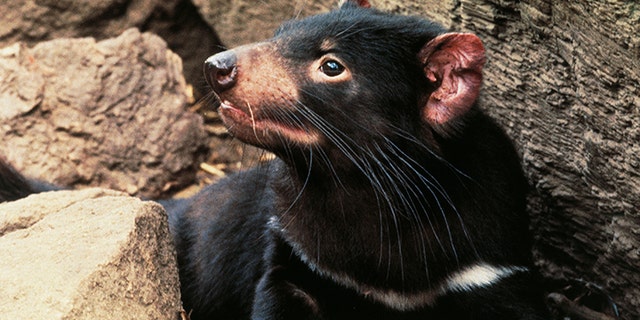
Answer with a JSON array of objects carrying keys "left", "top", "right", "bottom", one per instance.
[{"left": 0, "top": 29, "right": 206, "bottom": 197}]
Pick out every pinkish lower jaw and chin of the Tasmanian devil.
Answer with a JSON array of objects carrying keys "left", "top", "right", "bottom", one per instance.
[{"left": 218, "top": 100, "right": 320, "bottom": 149}]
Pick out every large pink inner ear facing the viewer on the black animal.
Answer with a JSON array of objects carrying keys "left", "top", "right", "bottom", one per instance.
[{"left": 418, "top": 33, "right": 485, "bottom": 125}]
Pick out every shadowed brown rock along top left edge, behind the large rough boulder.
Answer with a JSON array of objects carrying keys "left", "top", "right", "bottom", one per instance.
[{"left": 0, "top": 0, "right": 220, "bottom": 85}]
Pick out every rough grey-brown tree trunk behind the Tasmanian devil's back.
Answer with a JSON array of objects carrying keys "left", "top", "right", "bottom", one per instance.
[{"left": 373, "top": 0, "right": 640, "bottom": 319}]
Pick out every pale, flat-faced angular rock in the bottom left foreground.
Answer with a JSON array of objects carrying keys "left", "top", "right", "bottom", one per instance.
[{"left": 0, "top": 189, "right": 181, "bottom": 320}]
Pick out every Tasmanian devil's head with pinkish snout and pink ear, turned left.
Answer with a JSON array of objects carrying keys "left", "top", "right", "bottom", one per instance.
[{"left": 204, "top": 1, "right": 485, "bottom": 168}]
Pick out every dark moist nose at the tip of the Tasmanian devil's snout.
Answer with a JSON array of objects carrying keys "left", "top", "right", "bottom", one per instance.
[{"left": 204, "top": 50, "right": 238, "bottom": 93}]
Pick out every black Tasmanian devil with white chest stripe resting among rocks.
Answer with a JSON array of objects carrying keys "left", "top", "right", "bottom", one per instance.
[{"left": 0, "top": 1, "right": 547, "bottom": 320}]
